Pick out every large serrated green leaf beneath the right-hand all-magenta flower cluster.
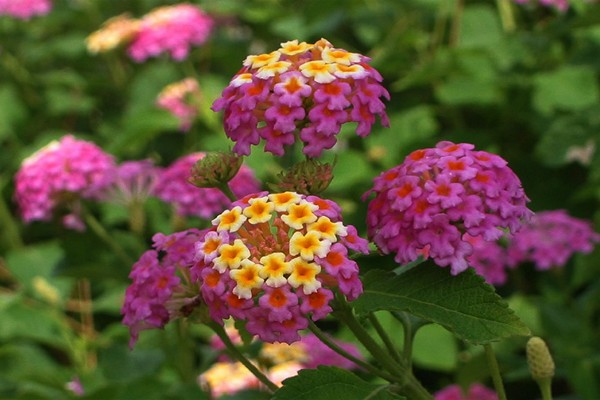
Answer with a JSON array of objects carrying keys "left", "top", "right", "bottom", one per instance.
[{"left": 353, "top": 264, "right": 530, "bottom": 344}]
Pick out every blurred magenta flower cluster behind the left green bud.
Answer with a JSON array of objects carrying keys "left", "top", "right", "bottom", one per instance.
[{"left": 154, "top": 153, "right": 260, "bottom": 218}]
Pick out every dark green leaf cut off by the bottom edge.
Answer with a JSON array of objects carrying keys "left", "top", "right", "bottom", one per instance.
[{"left": 273, "top": 366, "right": 405, "bottom": 400}]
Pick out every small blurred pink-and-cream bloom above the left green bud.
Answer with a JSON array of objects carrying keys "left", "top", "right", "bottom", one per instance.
[{"left": 156, "top": 78, "right": 201, "bottom": 132}]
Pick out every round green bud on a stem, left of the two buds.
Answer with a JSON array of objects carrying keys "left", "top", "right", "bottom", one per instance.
[{"left": 189, "top": 151, "right": 243, "bottom": 188}]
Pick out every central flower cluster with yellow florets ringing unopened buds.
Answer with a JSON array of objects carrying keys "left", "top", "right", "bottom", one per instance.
[{"left": 193, "top": 192, "right": 368, "bottom": 343}]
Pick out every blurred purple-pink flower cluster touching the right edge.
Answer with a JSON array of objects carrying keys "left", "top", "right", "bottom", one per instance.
[{"left": 508, "top": 210, "right": 600, "bottom": 270}]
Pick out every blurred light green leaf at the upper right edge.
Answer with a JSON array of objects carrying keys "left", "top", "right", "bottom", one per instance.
[{"left": 533, "top": 66, "right": 600, "bottom": 114}]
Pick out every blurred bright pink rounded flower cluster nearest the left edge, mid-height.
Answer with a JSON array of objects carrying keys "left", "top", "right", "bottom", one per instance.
[{"left": 15, "top": 135, "right": 115, "bottom": 230}]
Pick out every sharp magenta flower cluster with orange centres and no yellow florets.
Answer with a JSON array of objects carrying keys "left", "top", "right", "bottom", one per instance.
[{"left": 367, "top": 141, "right": 531, "bottom": 274}]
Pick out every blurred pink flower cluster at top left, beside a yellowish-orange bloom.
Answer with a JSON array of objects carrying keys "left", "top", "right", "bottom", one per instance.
[{"left": 128, "top": 3, "right": 213, "bottom": 62}]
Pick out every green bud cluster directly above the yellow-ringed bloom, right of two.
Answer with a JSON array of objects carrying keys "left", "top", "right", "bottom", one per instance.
[{"left": 270, "top": 159, "right": 333, "bottom": 195}]
